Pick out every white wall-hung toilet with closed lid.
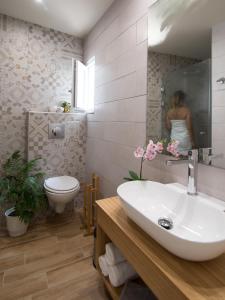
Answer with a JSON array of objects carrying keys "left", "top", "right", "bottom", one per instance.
[{"left": 44, "top": 176, "right": 80, "bottom": 214}]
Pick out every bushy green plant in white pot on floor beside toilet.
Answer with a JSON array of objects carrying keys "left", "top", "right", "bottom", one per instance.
[{"left": 0, "top": 151, "right": 47, "bottom": 236}]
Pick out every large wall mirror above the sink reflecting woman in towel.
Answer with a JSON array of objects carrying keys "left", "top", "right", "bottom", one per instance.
[{"left": 146, "top": 0, "right": 225, "bottom": 168}]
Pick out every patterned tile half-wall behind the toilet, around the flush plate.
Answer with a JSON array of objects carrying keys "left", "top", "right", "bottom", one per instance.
[{"left": 27, "top": 112, "right": 87, "bottom": 207}]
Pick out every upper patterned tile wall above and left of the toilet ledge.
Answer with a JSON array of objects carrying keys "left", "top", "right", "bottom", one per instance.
[{"left": 0, "top": 15, "right": 83, "bottom": 168}]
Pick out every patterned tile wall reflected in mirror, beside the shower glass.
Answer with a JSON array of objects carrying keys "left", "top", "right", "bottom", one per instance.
[{"left": 146, "top": 51, "right": 198, "bottom": 142}]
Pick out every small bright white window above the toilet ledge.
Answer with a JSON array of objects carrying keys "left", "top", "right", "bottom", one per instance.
[{"left": 75, "top": 57, "right": 95, "bottom": 113}]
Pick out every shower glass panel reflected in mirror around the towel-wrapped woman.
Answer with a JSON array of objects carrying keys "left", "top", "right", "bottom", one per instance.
[{"left": 161, "top": 59, "right": 211, "bottom": 148}]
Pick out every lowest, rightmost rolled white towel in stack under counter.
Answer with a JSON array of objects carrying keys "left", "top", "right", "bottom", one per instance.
[{"left": 108, "top": 261, "right": 137, "bottom": 287}]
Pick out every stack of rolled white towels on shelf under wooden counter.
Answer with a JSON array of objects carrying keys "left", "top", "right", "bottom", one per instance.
[{"left": 99, "top": 243, "right": 137, "bottom": 287}]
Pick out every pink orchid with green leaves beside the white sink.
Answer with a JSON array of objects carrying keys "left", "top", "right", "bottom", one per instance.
[{"left": 124, "top": 140, "right": 179, "bottom": 181}]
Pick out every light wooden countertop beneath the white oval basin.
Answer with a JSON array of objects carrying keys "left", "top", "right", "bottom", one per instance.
[{"left": 97, "top": 197, "right": 225, "bottom": 300}]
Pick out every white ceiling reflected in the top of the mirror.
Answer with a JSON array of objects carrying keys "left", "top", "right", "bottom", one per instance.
[{"left": 149, "top": 0, "right": 225, "bottom": 59}]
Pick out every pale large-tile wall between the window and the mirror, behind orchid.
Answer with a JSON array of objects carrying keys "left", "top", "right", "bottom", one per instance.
[{"left": 85, "top": 0, "right": 147, "bottom": 196}]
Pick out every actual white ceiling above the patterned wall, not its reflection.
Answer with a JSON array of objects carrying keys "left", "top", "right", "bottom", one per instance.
[{"left": 0, "top": 0, "right": 114, "bottom": 38}]
